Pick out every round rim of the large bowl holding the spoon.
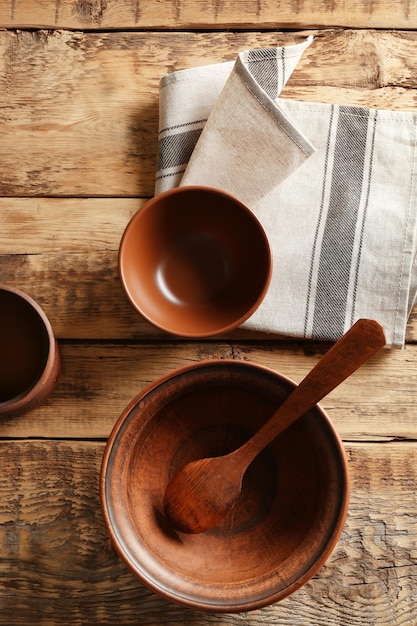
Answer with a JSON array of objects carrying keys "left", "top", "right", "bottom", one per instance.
[{"left": 99, "top": 358, "right": 351, "bottom": 613}]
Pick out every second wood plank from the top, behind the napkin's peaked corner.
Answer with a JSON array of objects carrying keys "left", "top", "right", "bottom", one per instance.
[{"left": 0, "top": 28, "right": 417, "bottom": 197}]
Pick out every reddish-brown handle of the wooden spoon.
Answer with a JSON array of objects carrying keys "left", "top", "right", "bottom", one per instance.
[{"left": 232, "top": 319, "right": 386, "bottom": 467}]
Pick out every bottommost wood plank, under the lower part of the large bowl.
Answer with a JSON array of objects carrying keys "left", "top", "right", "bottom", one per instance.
[{"left": 0, "top": 441, "right": 417, "bottom": 626}]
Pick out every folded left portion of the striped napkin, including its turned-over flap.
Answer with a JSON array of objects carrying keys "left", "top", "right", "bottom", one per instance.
[{"left": 155, "top": 36, "right": 314, "bottom": 197}]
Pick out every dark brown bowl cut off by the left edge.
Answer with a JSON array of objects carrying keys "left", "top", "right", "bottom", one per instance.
[{"left": 0, "top": 285, "right": 60, "bottom": 416}]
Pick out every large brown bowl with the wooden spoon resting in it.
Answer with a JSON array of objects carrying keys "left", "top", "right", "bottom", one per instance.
[{"left": 100, "top": 360, "right": 349, "bottom": 612}]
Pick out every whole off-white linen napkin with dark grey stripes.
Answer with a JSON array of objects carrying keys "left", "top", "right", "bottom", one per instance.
[{"left": 155, "top": 37, "right": 417, "bottom": 347}]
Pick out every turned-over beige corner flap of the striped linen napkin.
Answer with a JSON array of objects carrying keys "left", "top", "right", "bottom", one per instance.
[{"left": 180, "top": 37, "right": 315, "bottom": 206}]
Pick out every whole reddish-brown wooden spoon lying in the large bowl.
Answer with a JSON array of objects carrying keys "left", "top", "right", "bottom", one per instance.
[{"left": 164, "top": 319, "right": 385, "bottom": 533}]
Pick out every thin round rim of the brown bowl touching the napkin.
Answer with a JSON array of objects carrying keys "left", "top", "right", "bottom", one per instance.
[{"left": 118, "top": 185, "right": 273, "bottom": 339}]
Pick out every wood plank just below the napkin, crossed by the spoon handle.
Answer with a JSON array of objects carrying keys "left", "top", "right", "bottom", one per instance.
[{"left": 0, "top": 341, "right": 417, "bottom": 441}]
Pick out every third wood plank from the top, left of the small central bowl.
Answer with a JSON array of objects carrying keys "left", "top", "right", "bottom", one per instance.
[{"left": 0, "top": 198, "right": 417, "bottom": 342}]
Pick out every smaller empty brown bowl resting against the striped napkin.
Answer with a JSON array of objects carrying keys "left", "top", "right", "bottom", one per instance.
[{"left": 119, "top": 186, "right": 272, "bottom": 337}]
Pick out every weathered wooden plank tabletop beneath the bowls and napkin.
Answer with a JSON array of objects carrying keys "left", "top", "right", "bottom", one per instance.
[{"left": 0, "top": 0, "right": 417, "bottom": 626}]
